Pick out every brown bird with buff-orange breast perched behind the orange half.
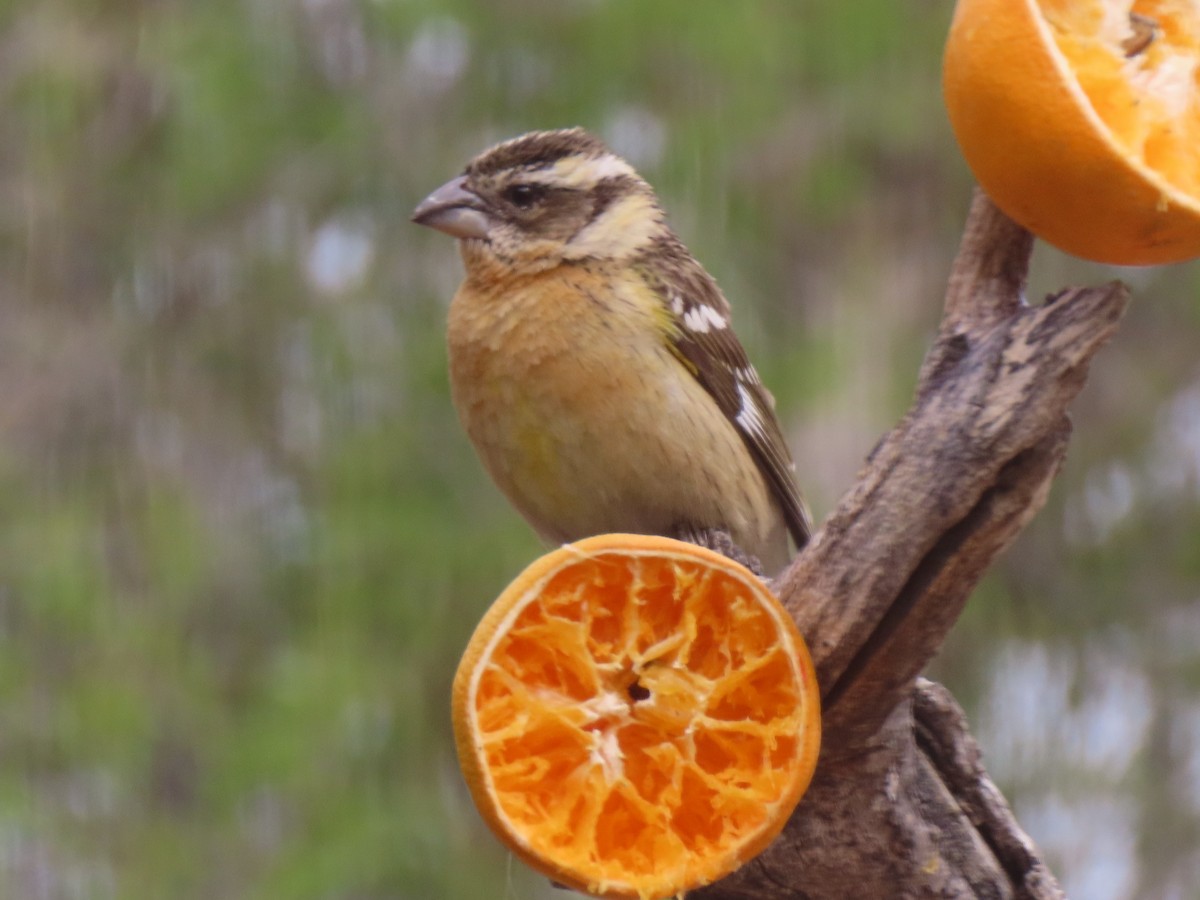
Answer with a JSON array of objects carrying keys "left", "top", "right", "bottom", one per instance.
[{"left": 413, "top": 128, "right": 811, "bottom": 574}]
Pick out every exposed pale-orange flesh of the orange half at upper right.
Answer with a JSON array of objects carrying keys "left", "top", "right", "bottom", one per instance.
[{"left": 1038, "top": 0, "right": 1200, "bottom": 197}]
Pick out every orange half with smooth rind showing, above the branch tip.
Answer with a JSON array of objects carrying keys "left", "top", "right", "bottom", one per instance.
[{"left": 942, "top": 0, "right": 1200, "bottom": 265}]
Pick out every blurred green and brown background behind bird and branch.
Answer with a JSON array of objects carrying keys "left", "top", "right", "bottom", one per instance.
[{"left": 7, "top": 0, "right": 1200, "bottom": 900}]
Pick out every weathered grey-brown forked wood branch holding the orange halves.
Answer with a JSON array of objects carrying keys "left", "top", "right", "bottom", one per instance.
[{"left": 689, "top": 193, "right": 1128, "bottom": 900}]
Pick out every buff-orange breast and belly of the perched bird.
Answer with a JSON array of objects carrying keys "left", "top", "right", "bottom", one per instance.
[{"left": 449, "top": 264, "right": 782, "bottom": 566}]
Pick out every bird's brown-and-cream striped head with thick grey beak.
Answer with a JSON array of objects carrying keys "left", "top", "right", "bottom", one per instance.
[{"left": 413, "top": 128, "right": 667, "bottom": 274}]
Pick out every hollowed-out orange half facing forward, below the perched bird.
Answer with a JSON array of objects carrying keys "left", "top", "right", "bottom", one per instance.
[{"left": 454, "top": 534, "right": 821, "bottom": 900}]
